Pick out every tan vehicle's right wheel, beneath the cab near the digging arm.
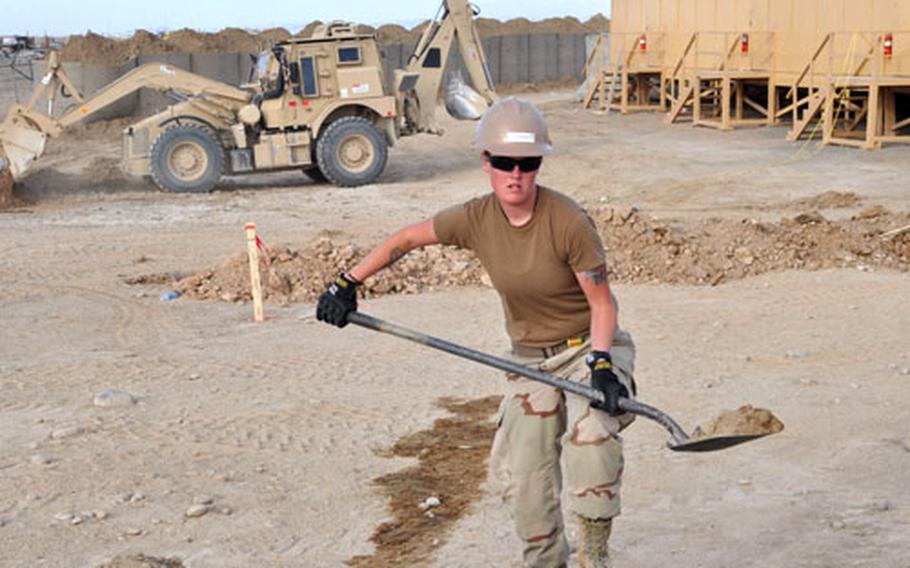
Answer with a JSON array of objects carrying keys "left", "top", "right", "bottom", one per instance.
[{"left": 316, "top": 116, "right": 389, "bottom": 187}]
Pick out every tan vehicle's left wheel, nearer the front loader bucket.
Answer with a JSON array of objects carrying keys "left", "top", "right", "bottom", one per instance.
[{"left": 149, "top": 124, "right": 224, "bottom": 193}]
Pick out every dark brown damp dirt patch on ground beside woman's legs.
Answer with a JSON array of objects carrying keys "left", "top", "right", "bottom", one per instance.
[{"left": 348, "top": 396, "right": 501, "bottom": 568}]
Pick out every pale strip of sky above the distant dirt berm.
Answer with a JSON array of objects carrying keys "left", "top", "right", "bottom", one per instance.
[{"left": 0, "top": 0, "right": 611, "bottom": 36}]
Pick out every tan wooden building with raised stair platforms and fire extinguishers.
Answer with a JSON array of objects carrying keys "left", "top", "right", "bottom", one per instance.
[{"left": 600, "top": 0, "right": 910, "bottom": 149}]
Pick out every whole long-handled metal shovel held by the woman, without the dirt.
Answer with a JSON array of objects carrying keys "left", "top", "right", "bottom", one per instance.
[{"left": 348, "top": 312, "right": 767, "bottom": 452}]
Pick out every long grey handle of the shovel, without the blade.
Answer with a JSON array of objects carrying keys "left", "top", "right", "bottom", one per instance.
[{"left": 348, "top": 312, "right": 689, "bottom": 444}]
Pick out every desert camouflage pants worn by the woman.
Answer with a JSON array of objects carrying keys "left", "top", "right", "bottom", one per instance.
[{"left": 490, "top": 331, "right": 635, "bottom": 568}]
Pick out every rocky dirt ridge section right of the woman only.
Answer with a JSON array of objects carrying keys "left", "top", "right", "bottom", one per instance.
[{"left": 592, "top": 207, "right": 910, "bottom": 285}]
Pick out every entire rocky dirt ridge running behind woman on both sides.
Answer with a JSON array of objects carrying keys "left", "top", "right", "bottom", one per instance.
[{"left": 159, "top": 206, "right": 910, "bottom": 305}]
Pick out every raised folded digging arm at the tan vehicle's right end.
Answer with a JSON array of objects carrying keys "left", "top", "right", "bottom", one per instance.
[{"left": 395, "top": 0, "right": 498, "bottom": 134}]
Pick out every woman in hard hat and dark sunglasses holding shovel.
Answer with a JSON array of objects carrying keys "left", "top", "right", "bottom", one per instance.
[{"left": 317, "top": 97, "right": 635, "bottom": 568}]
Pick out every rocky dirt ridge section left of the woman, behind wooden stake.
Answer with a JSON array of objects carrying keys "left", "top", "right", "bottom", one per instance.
[{"left": 176, "top": 238, "right": 486, "bottom": 305}]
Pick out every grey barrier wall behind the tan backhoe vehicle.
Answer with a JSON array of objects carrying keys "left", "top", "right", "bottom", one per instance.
[{"left": 0, "top": 33, "right": 587, "bottom": 121}]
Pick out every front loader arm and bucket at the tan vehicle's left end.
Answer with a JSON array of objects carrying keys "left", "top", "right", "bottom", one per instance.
[{"left": 0, "top": 53, "right": 253, "bottom": 179}]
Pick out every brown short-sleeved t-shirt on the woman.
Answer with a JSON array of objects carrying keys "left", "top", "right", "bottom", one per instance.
[{"left": 433, "top": 187, "right": 606, "bottom": 347}]
